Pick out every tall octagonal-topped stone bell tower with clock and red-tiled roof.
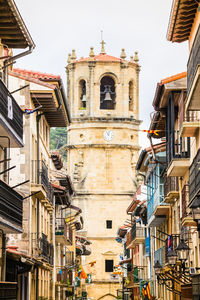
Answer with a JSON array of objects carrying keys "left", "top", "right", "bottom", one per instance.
[{"left": 66, "top": 41, "right": 140, "bottom": 299}]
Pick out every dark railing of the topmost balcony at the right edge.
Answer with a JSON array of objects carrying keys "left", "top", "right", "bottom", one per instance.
[{"left": 187, "top": 26, "right": 200, "bottom": 92}]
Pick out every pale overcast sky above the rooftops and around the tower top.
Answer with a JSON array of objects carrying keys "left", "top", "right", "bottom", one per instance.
[{"left": 15, "top": 0, "right": 188, "bottom": 145}]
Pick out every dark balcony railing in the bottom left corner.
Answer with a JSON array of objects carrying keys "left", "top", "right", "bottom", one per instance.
[{"left": 0, "top": 281, "right": 17, "bottom": 300}]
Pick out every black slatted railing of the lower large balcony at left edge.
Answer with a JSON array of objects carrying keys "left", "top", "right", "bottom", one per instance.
[{"left": 0, "top": 180, "right": 23, "bottom": 227}]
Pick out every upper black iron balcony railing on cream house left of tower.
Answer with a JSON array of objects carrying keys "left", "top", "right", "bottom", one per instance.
[{"left": 31, "top": 160, "right": 54, "bottom": 205}]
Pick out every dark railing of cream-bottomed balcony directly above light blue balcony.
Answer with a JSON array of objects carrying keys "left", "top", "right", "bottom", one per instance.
[{"left": 166, "top": 130, "right": 190, "bottom": 165}]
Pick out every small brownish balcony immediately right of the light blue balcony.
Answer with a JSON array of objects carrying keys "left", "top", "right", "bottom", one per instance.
[{"left": 164, "top": 174, "right": 179, "bottom": 203}]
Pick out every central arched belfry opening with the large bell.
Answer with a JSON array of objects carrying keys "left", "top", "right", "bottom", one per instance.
[{"left": 100, "top": 76, "right": 116, "bottom": 109}]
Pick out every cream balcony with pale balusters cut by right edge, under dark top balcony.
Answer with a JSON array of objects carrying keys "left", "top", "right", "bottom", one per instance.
[{"left": 179, "top": 93, "right": 200, "bottom": 137}]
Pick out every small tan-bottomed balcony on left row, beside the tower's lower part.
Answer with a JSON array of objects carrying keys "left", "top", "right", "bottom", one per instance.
[{"left": 55, "top": 218, "right": 73, "bottom": 245}]
